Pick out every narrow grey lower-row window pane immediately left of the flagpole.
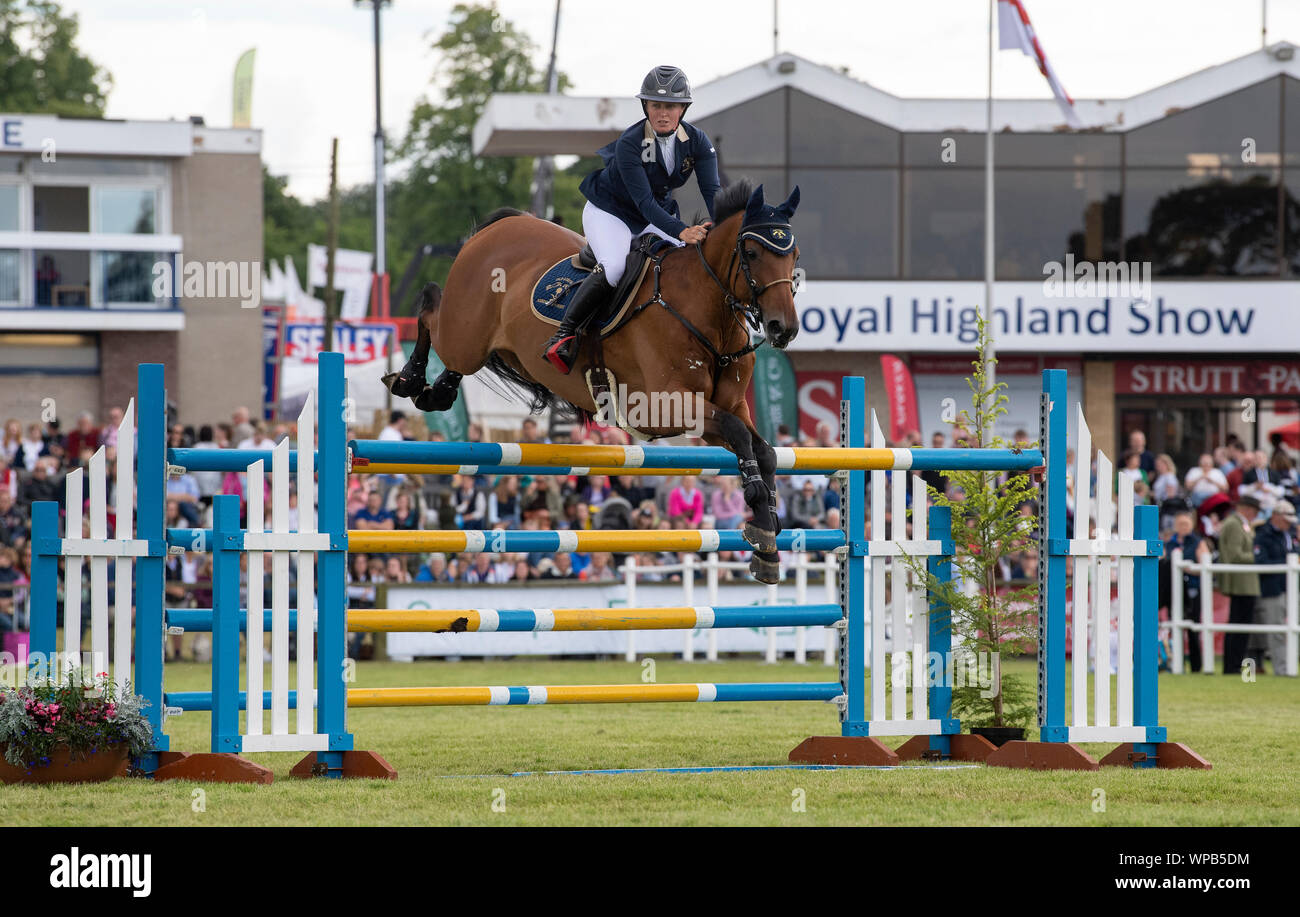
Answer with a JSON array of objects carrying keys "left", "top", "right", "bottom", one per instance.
[{"left": 902, "top": 168, "right": 984, "bottom": 280}]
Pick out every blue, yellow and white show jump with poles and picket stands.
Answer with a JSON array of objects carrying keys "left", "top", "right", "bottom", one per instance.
[{"left": 33, "top": 354, "right": 1209, "bottom": 782}]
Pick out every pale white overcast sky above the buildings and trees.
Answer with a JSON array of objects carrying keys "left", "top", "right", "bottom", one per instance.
[{"left": 62, "top": 0, "right": 1300, "bottom": 200}]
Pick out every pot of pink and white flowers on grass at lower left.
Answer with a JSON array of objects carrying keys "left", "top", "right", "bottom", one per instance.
[{"left": 0, "top": 669, "right": 153, "bottom": 783}]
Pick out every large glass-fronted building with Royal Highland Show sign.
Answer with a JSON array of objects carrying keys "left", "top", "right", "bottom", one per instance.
[{"left": 475, "top": 43, "right": 1300, "bottom": 470}]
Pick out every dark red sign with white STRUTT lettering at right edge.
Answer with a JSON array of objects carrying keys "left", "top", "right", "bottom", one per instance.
[{"left": 1115, "top": 360, "right": 1300, "bottom": 398}]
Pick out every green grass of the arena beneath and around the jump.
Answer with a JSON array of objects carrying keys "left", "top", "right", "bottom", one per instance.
[{"left": 0, "top": 659, "right": 1300, "bottom": 826}]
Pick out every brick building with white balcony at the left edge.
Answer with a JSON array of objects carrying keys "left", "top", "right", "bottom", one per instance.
[{"left": 0, "top": 114, "right": 263, "bottom": 429}]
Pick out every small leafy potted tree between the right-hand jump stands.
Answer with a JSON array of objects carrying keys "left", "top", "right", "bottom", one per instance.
[{"left": 907, "top": 320, "right": 1039, "bottom": 727}]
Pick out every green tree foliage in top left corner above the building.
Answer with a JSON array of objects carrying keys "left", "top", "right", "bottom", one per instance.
[{"left": 0, "top": 0, "right": 113, "bottom": 117}]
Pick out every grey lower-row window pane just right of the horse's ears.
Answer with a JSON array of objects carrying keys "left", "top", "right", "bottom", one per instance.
[{"left": 790, "top": 169, "right": 898, "bottom": 281}]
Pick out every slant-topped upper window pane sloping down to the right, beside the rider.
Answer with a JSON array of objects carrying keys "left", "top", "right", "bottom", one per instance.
[{"left": 789, "top": 90, "right": 898, "bottom": 166}]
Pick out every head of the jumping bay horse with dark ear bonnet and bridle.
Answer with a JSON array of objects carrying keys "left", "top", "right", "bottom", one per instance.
[{"left": 736, "top": 185, "right": 800, "bottom": 349}]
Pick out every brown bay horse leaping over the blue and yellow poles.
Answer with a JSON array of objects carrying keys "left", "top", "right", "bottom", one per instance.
[{"left": 384, "top": 181, "right": 800, "bottom": 583}]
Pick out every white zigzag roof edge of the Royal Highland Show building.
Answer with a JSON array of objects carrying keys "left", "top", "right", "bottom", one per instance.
[{"left": 473, "top": 42, "right": 1300, "bottom": 156}]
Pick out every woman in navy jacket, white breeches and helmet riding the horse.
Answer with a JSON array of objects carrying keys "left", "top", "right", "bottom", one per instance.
[{"left": 543, "top": 66, "right": 720, "bottom": 373}]
